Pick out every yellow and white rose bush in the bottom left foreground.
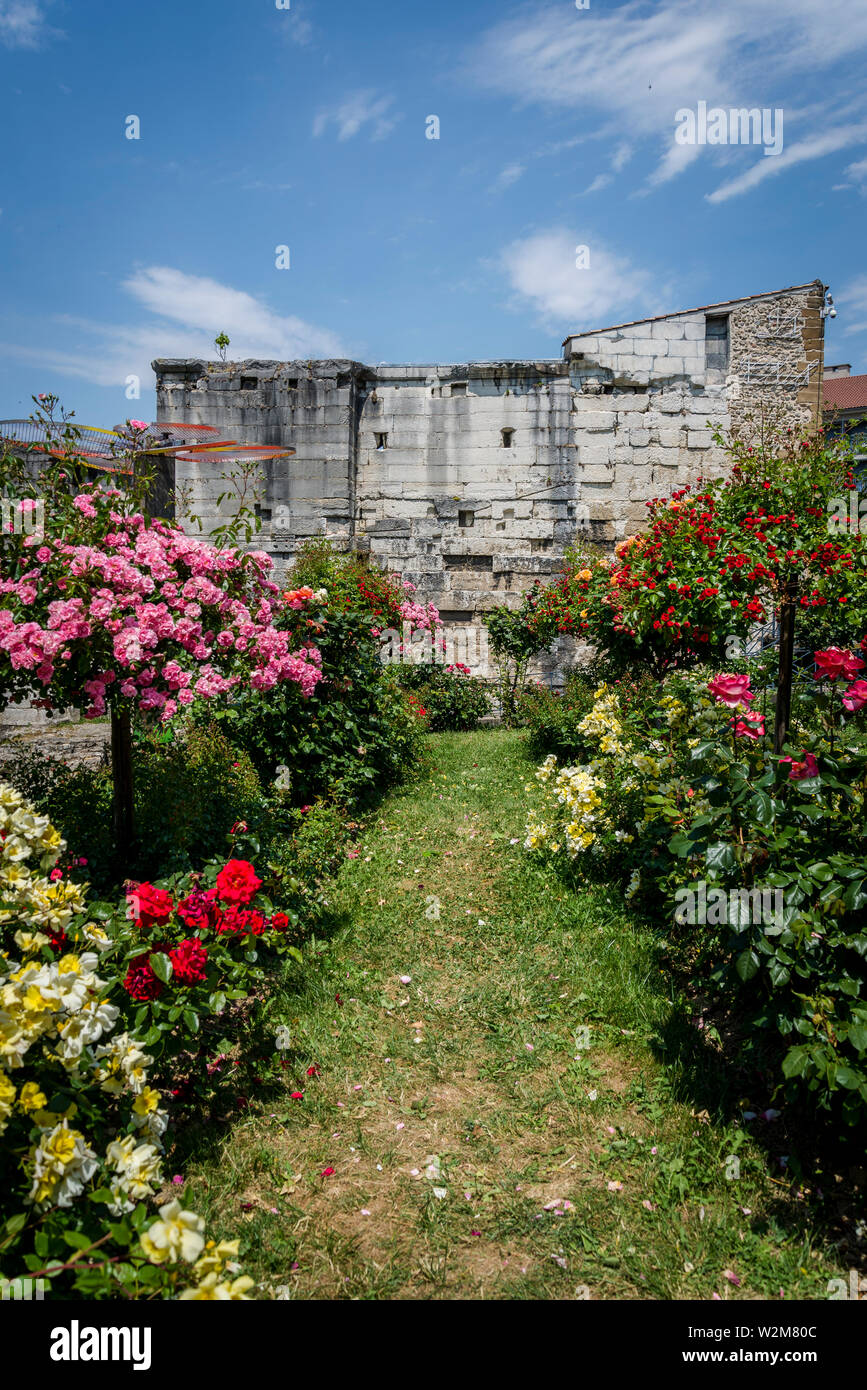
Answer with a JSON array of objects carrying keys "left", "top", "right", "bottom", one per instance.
[{"left": 0, "top": 785, "right": 249, "bottom": 1298}]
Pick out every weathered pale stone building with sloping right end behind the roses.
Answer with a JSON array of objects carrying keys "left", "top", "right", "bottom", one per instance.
[{"left": 154, "top": 273, "right": 825, "bottom": 666}]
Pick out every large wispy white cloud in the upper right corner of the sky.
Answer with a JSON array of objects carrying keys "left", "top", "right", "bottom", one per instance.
[{"left": 465, "top": 0, "right": 867, "bottom": 188}]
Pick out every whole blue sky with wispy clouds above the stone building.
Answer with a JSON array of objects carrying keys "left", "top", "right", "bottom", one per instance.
[{"left": 0, "top": 0, "right": 867, "bottom": 425}]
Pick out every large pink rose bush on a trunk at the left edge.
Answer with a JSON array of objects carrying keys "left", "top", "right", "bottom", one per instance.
[{"left": 0, "top": 487, "right": 322, "bottom": 721}]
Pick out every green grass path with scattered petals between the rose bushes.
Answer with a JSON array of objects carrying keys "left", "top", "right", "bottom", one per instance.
[{"left": 187, "top": 730, "right": 845, "bottom": 1300}]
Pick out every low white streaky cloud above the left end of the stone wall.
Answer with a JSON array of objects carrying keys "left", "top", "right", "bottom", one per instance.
[{"left": 0, "top": 265, "right": 345, "bottom": 389}]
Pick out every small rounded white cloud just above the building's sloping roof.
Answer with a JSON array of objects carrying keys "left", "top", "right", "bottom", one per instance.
[{"left": 499, "top": 227, "right": 653, "bottom": 334}]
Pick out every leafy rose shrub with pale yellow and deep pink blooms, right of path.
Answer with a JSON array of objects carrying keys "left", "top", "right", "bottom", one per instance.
[{"left": 525, "top": 649, "right": 867, "bottom": 1125}]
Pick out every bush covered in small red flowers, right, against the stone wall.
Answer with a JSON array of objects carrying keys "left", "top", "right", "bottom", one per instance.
[{"left": 494, "top": 431, "right": 867, "bottom": 673}]
